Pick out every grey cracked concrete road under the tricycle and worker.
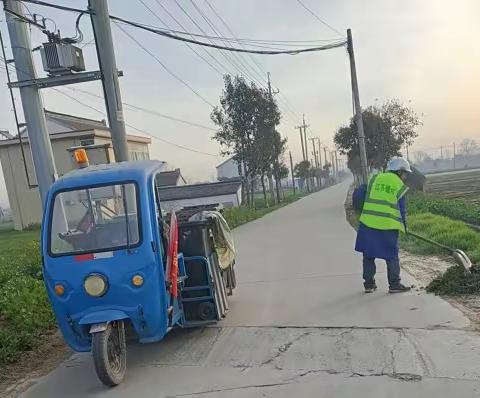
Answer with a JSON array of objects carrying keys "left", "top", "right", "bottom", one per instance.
[{"left": 25, "top": 183, "right": 480, "bottom": 398}]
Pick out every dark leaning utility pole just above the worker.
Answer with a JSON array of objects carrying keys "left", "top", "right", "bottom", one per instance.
[{"left": 347, "top": 29, "right": 368, "bottom": 183}]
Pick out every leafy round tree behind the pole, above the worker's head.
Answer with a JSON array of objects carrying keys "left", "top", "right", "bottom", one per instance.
[{"left": 334, "top": 100, "right": 422, "bottom": 174}]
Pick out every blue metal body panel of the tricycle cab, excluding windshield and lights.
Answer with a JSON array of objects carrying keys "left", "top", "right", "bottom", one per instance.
[{"left": 41, "top": 161, "right": 175, "bottom": 351}]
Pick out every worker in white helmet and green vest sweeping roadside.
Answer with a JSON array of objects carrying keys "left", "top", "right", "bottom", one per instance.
[{"left": 353, "top": 158, "right": 412, "bottom": 293}]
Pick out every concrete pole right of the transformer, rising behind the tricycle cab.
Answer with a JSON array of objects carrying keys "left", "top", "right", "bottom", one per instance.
[{"left": 89, "top": 0, "right": 128, "bottom": 162}]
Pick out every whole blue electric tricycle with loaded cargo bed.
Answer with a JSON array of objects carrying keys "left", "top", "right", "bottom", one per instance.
[{"left": 41, "top": 161, "right": 235, "bottom": 386}]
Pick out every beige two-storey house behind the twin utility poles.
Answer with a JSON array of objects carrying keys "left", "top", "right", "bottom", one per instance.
[{"left": 0, "top": 111, "right": 151, "bottom": 230}]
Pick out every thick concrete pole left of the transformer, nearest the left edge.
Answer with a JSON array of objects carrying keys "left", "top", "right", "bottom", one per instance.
[{"left": 4, "top": 0, "right": 57, "bottom": 206}]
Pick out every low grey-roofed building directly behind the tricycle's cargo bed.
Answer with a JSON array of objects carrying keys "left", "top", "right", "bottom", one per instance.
[{"left": 158, "top": 179, "right": 242, "bottom": 213}]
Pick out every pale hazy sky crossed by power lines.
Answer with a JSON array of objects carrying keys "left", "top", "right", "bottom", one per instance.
[{"left": 0, "top": 0, "right": 480, "bottom": 206}]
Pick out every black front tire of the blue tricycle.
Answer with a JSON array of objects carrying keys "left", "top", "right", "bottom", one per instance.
[{"left": 92, "top": 321, "right": 127, "bottom": 387}]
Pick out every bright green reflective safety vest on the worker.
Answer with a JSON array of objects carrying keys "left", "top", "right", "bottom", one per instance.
[{"left": 360, "top": 173, "right": 408, "bottom": 232}]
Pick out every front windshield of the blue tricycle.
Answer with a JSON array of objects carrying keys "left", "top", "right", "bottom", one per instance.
[{"left": 49, "top": 183, "right": 141, "bottom": 256}]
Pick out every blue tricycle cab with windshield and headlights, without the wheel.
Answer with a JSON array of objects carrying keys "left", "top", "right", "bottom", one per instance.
[{"left": 41, "top": 161, "right": 173, "bottom": 351}]
